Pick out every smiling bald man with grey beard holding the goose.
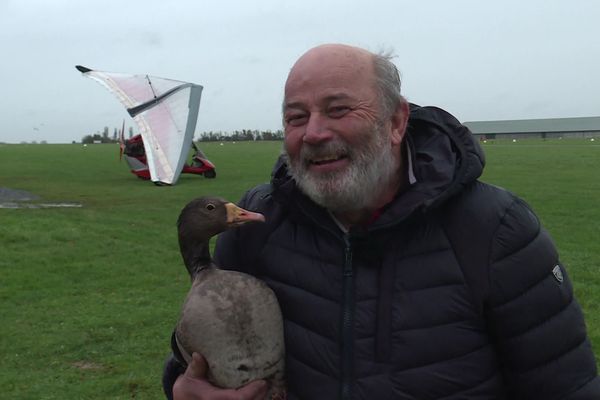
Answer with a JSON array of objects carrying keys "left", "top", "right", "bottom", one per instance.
[{"left": 166, "top": 45, "right": 600, "bottom": 400}]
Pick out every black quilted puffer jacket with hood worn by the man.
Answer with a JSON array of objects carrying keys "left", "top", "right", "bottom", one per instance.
[{"left": 210, "top": 106, "right": 600, "bottom": 400}]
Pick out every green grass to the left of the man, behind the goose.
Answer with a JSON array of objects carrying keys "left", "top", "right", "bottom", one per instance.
[{"left": 0, "top": 142, "right": 281, "bottom": 400}]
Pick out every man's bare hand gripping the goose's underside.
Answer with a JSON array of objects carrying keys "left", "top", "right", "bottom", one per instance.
[{"left": 173, "top": 353, "right": 268, "bottom": 400}]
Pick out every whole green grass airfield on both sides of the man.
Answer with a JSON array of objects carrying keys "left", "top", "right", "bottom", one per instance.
[{"left": 0, "top": 140, "right": 600, "bottom": 400}]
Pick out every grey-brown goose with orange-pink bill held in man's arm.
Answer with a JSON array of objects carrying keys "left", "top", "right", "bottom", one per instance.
[{"left": 173, "top": 197, "right": 285, "bottom": 399}]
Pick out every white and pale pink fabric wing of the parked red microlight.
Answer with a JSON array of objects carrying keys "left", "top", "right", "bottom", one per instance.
[{"left": 75, "top": 65, "right": 202, "bottom": 185}]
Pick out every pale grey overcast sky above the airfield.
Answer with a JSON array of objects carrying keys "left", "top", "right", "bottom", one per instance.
[{"left": 0, "top": 0, "right": 600, "bottom": 143}]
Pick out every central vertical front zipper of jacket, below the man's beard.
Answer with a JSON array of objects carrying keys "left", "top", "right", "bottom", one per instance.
[{"left": 340, "top": 234, "right": 354, "bottom": 400}]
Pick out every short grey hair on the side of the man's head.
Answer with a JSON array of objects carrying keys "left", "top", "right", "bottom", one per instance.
[{"left": 373, "top": 52, "right": 406, "bottom": 116}]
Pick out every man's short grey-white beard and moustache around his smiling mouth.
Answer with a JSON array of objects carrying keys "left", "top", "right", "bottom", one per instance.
[{"left": 285, "top": 126, "right": 399, "bottom": 212}]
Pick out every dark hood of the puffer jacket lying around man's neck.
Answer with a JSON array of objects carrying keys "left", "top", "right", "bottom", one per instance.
[{"left": 271, "top": 104, "right": 485, "bottom": 228}]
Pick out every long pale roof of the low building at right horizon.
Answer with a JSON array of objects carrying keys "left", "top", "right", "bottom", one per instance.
[{"left": 463, "top": 117, "right": 600, "bottom": 134}]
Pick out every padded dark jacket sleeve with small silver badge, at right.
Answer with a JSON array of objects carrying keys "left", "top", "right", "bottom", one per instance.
[{"left": 487, "top": 199, "right": 600, "bottom": 400}]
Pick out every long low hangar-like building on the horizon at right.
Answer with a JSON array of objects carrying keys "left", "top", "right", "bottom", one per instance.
[{"left": 464, "top": 117, "right": 600, "bottom": 139}]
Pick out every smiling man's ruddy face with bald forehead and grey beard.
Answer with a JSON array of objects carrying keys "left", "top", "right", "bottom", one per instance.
[{"left": 283, "top": 45, "right": 399, "bottom": 212}]
